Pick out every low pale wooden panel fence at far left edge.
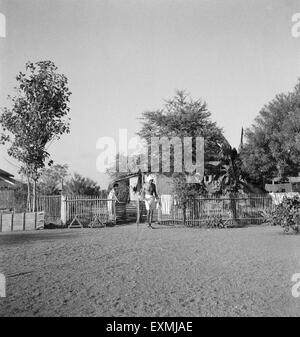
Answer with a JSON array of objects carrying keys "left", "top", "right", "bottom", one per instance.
[{"left": 0, "top": 212, "right": 45, "bottom": 232}]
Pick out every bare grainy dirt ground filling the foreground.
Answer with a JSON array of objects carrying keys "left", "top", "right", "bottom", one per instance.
[{"left": 0, "top": 224, "right": 300, "bottom": 316}]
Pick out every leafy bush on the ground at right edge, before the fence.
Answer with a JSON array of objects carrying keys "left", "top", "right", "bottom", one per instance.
[{"left": 264, "top": 196, "right": 300, "bottom": 234}]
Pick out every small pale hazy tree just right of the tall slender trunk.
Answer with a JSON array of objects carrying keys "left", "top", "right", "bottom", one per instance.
[{"left": 37, "top": 164, "right": 69, "bottom": 195}]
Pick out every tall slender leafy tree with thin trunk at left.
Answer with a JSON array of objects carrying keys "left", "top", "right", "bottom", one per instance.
[{"left": 0, "top": 61, "right": 71, "bottom": 210}]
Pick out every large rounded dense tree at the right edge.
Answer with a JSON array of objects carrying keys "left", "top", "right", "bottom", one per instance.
[{"left": 241, "top": 79, "right": 300, "bottom": 185}]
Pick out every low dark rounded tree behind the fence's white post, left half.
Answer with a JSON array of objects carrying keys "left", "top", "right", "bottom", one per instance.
[{"left": 65, "top": 173, "right": 100, "bottom": 195}]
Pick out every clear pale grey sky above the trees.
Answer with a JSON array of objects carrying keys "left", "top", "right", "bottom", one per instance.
[{"left": 0, "top": 0, "right": 300, "bottom": 188}]
